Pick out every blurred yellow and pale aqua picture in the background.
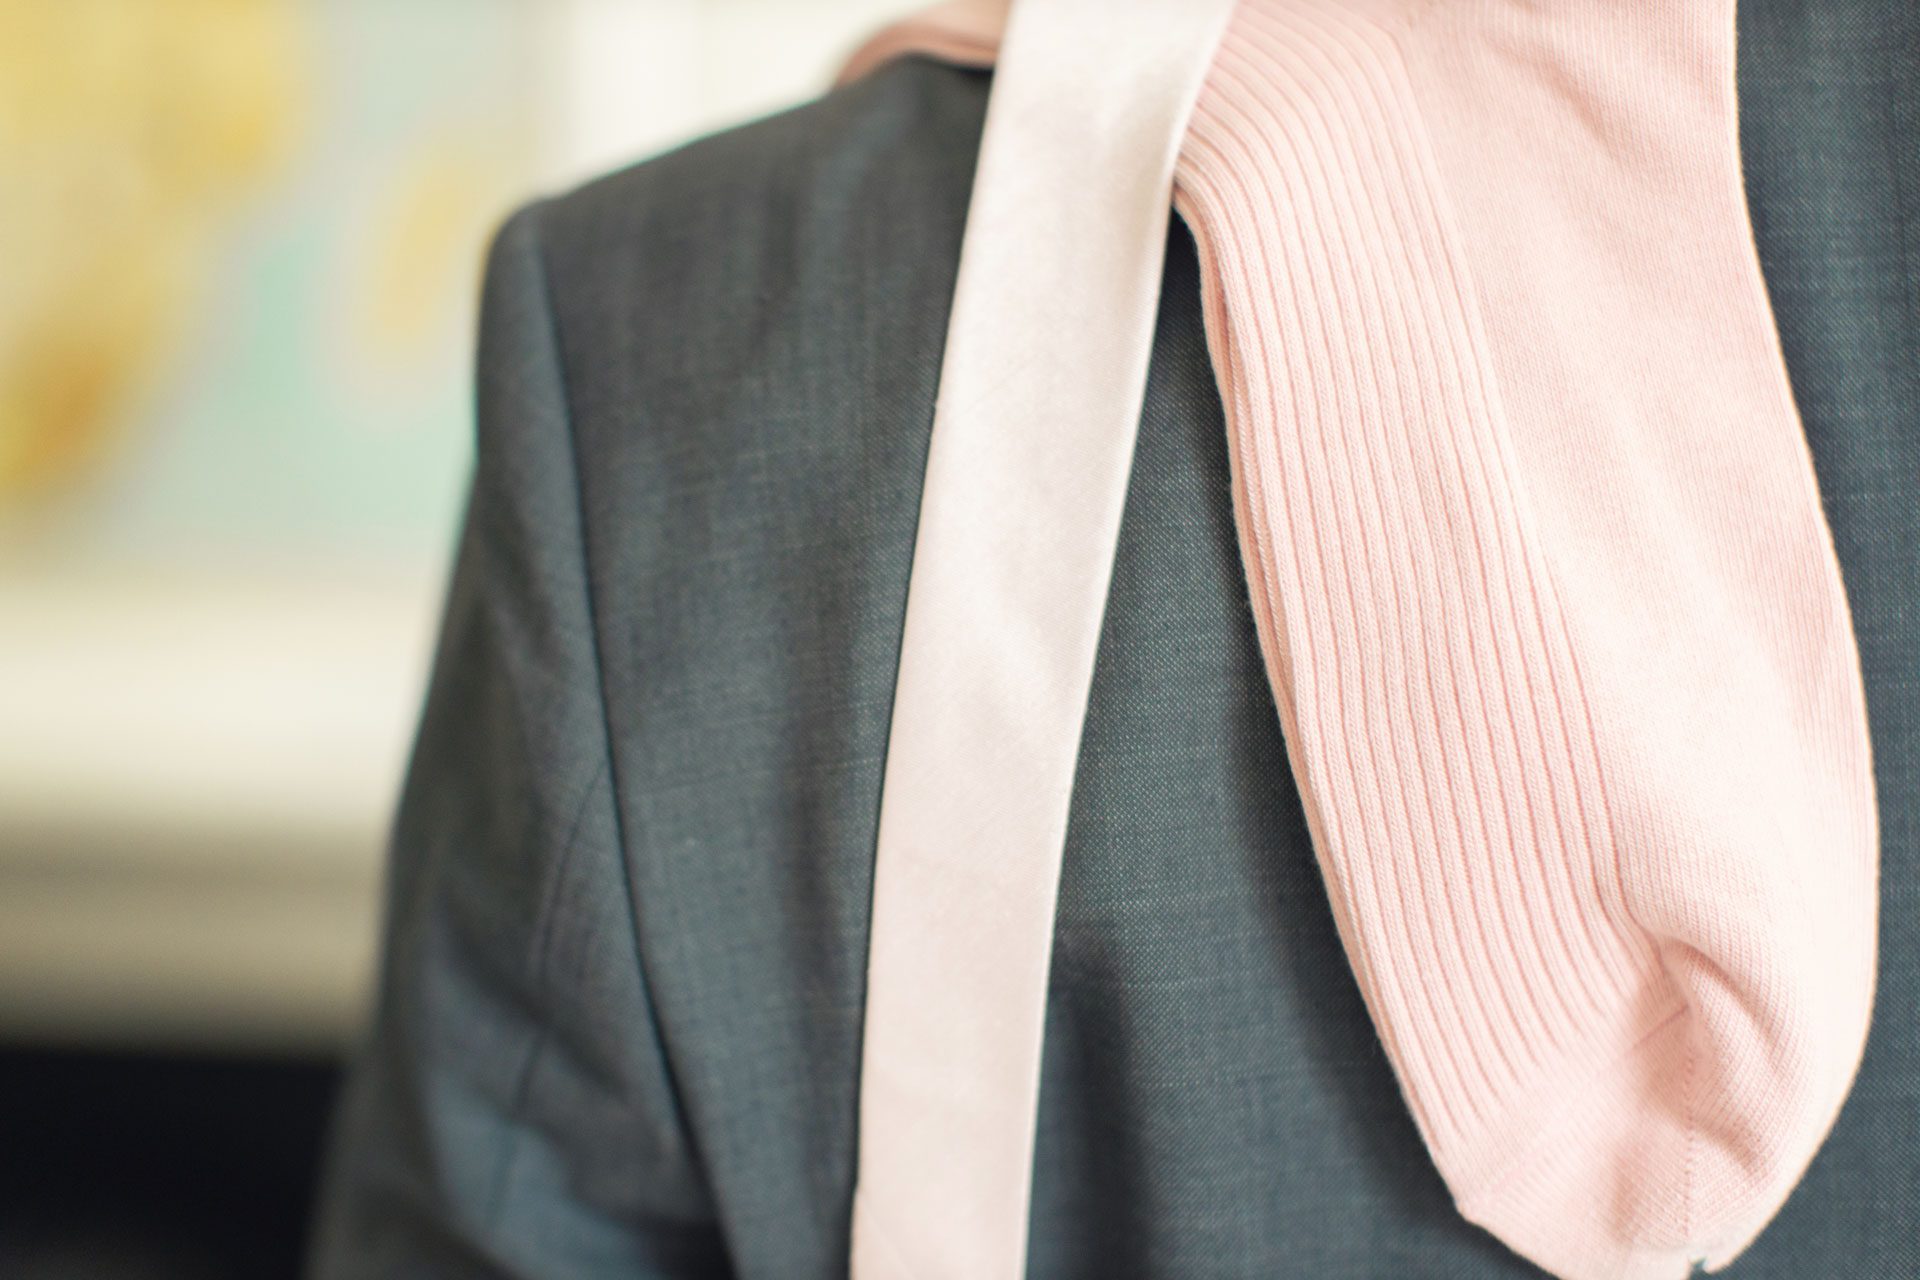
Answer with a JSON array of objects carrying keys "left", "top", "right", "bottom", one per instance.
[{"left": 0, "top": 0, "right": 536, "bottom": 564}]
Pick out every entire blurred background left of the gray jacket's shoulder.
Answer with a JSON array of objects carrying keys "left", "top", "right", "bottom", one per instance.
[{"left": 0, "top": 0, "right": 902, "bottom": 1280}]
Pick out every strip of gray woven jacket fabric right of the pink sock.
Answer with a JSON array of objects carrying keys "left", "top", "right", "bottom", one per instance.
[{"left": 1728, "top": 0, "right": 1920, "bottom": 1280}]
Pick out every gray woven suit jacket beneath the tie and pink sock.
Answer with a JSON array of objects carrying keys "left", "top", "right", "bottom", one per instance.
[{"left": 313, "top": 0, "right": 1920, "bottom": 1280}]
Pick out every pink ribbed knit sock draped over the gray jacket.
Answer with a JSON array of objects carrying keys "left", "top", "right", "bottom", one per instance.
[{"left": 851, "top": 0, "right": 1878, "bottom": 1278}]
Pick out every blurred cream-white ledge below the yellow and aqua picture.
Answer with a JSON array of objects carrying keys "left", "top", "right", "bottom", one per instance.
[{"left": 0, "top": 570, "right": 440, "bottom": 1050}]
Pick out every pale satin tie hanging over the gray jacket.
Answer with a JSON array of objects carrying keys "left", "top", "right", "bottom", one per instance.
[{"left": 852, "top": 0, "right": 1231, "bottom": 1280}]
